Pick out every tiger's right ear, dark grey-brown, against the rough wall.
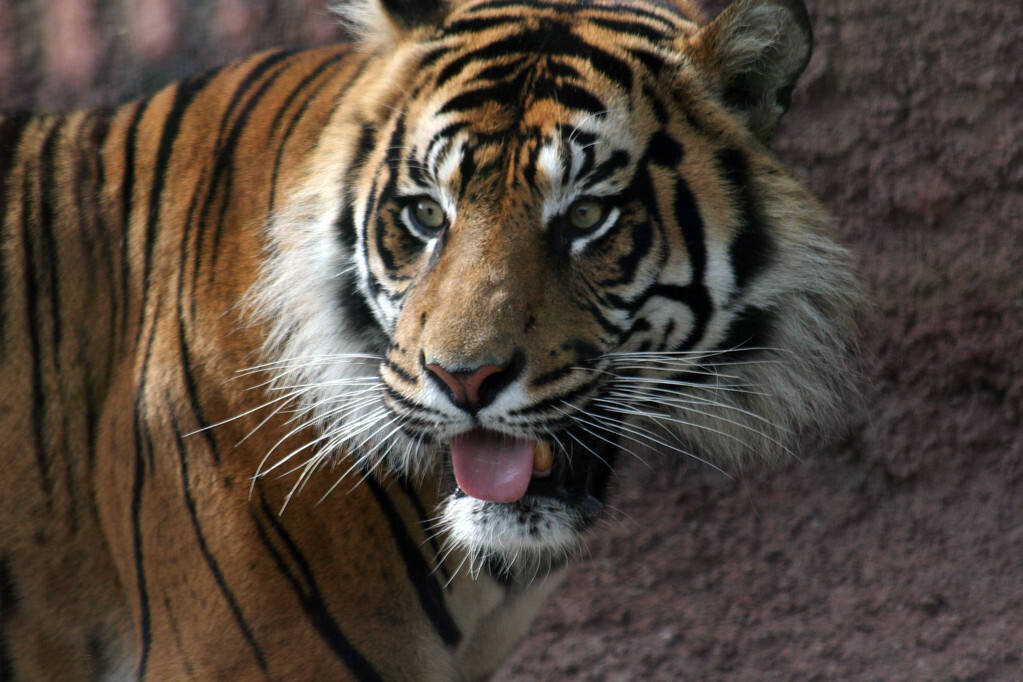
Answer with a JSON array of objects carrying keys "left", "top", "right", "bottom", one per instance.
[{"left": 687, "top": 0, "right": 813, "bottom": 142}]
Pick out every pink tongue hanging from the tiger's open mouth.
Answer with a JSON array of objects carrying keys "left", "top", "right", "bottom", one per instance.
[{"left": 451, "top": 428, "right": 535, "bottom": 502}]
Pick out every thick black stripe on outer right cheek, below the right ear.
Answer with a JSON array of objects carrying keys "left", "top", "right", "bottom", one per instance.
[{"left": 715, "top": 148, "right": 774, "bottom": 293}]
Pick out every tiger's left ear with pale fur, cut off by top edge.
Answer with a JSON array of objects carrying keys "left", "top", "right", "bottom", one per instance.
[{"left": 333, "top": 0, "right": 447, "bottom": 49}]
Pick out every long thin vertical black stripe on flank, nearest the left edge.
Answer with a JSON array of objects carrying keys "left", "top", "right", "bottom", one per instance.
[{"left": 21, "top": 174, "right": 53, "bottom": 501}]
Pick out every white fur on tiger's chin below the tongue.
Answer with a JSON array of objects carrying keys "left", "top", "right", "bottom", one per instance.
[{"left": 441, "top": 496, "right": 581, "bottom": 575}]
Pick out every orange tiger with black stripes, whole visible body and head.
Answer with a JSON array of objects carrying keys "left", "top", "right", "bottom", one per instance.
[{"left": 0, "top": 0, "right": 858, "bottom": 680}]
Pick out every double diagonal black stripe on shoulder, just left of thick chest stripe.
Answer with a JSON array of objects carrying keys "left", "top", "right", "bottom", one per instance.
[{"left": 253, "top": 487, "right": 383, "bottom": 682}]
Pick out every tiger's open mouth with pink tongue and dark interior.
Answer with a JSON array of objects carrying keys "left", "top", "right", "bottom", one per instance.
[{"left": 450, "top": 428, "right": 615, "bottom": 517}]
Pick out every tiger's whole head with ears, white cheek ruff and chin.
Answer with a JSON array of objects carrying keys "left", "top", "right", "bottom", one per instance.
[{"left": 253, "top": 0, "right": 855, "bottom": 576}]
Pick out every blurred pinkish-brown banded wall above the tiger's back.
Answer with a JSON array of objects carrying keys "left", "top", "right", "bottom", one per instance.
[{"left": 0, "top": 0, "right": 342, "bottom": 108}]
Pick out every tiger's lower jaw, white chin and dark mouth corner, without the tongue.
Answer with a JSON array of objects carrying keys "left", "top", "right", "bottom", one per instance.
[{"left": 431, "top": 436, "right": 616, "bottom": 580}]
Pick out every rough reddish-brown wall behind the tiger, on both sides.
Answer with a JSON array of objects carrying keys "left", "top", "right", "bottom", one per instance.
[{"left": 0, "top": 0, "right": 1023, "bottom": 682}]
